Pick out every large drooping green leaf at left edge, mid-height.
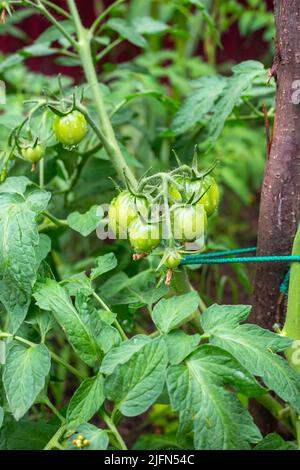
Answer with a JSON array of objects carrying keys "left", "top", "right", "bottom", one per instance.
[{"left": 0, "top": 177, "right": 50, "bottom": 332}]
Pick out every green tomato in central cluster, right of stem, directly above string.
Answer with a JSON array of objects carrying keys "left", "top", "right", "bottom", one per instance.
[{"left": 172, "top": 204, "right": 207, "bottom": 242}]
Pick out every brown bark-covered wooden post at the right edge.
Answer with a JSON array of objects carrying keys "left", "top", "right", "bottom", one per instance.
[{"left": 252, "top": 0, "right": 300, "bottom": 329}]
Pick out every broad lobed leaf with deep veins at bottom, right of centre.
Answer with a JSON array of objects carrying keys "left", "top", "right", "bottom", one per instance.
[{"left": 167, "top": 345, "right": 261, "bottom": 450}]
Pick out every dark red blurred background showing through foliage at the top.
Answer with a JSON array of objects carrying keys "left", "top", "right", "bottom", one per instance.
[{"left": 0, "top": 0, "right": 273, "bottom": 75}]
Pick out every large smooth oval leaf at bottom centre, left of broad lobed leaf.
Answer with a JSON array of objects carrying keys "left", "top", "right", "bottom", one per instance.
[{"left": 105, "top": 339, "right": 168, "bottom": 416}]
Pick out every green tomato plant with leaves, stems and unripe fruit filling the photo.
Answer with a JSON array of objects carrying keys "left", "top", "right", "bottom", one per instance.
[{"left": 0, "top": 0, "right": 300, "bottom": 451}]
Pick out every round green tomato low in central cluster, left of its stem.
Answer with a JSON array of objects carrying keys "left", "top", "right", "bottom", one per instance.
[{"left": 128, "top": 217, "right": 161, "bottom": 253}]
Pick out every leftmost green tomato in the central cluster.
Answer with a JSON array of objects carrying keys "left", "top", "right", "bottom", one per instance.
[{"left": 108, "top": 191, "right": 148, "bottom": 238}]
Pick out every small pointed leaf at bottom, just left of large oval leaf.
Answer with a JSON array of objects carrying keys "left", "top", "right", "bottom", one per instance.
[{"left": 67, "top": 374, "right": 105, "bottom": 429}]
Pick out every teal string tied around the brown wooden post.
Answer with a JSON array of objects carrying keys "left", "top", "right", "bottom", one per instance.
[{"left": 181, "top": 247, "right": 300, "bottom": 294}]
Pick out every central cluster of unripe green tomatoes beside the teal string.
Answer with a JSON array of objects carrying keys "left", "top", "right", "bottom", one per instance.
[{"left": 108, "top": 168, "right": 220, "bottom": 276}]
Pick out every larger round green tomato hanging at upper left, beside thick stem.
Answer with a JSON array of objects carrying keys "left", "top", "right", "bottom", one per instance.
[{"left": 53, "top": 111, "right": 88, "bottom": 145}]
